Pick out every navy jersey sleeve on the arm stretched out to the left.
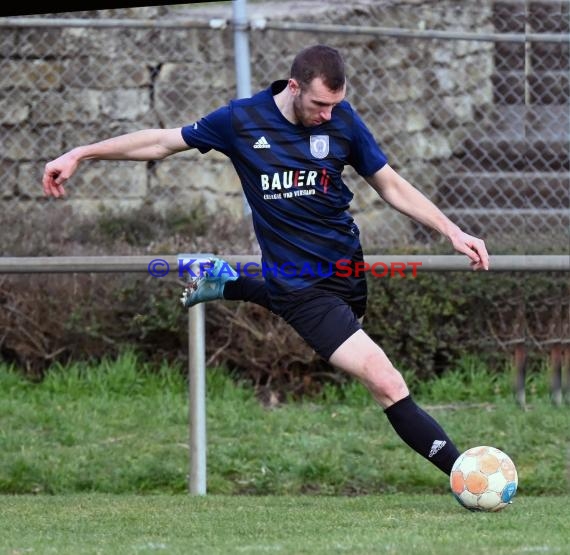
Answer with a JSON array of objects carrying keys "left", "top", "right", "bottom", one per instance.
[{"left": 182, "top": 106, "right": 232, "bottom": 155}]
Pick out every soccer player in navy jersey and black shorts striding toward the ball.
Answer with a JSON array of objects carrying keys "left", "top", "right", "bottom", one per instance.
[{"left": 43, "top": 44, "right": 489, "bottom": 474}]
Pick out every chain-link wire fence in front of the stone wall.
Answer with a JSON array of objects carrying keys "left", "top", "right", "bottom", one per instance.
[{"left": 0, "top": 1, "right": 570, "bottom": 254}]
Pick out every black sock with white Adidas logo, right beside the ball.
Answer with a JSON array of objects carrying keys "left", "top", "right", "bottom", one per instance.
[{"left": 384, "top": 395, "right": 460, "bottom": 475}]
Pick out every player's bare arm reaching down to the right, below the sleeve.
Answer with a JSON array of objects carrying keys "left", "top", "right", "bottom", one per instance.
[{"left": 366, "top": 164, "right": 489, "bottom": 270}]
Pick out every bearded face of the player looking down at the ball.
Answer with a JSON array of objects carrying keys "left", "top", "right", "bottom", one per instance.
[{"left": 289, "top": 77, "right": 346, "bottom": 127}]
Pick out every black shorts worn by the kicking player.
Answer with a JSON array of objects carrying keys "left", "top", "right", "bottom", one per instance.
[{"left": 271, "top": 250, "right": 368, "bottom": 360}]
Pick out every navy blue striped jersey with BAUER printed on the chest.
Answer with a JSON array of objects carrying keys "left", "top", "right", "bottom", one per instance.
[{"left": 182, "top": 81, "right": 387, "bottom": 294}]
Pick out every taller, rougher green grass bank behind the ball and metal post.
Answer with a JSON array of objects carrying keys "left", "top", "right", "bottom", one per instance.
[{"left": 0, "top": 353, "right": 570, "bottom": 495}]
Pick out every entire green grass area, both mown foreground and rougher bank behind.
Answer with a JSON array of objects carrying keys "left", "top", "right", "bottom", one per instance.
[{"left": 0, "top": 353, "right": 570, "bottom": 555}]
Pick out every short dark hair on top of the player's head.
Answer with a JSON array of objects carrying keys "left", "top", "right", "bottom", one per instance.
[{"left": 291, "top": 44, "right": 346, "bottom": 91}]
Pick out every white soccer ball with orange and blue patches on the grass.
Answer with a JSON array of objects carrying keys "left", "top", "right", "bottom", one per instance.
[{"left": 449, "top": 445, "right": 519, "bottom": 511}]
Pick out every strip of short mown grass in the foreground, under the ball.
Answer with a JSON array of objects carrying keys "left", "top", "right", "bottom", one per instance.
[{"left": 0, "top": 494, "right": 570, "bottom": 555}]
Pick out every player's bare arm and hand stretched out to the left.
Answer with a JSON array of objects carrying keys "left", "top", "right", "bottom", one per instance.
[{"left": 42, "top": 127, "right": 189, "bottom": 197}]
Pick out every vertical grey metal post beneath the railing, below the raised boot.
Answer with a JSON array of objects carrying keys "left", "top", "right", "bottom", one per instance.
[{"left": 188, "top": 304, "right": 206, "bottom": 495}]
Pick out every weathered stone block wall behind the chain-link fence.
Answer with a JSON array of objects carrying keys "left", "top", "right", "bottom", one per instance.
[{"left": 0, "top": 0, "right": 493, "bottom": 245}]
